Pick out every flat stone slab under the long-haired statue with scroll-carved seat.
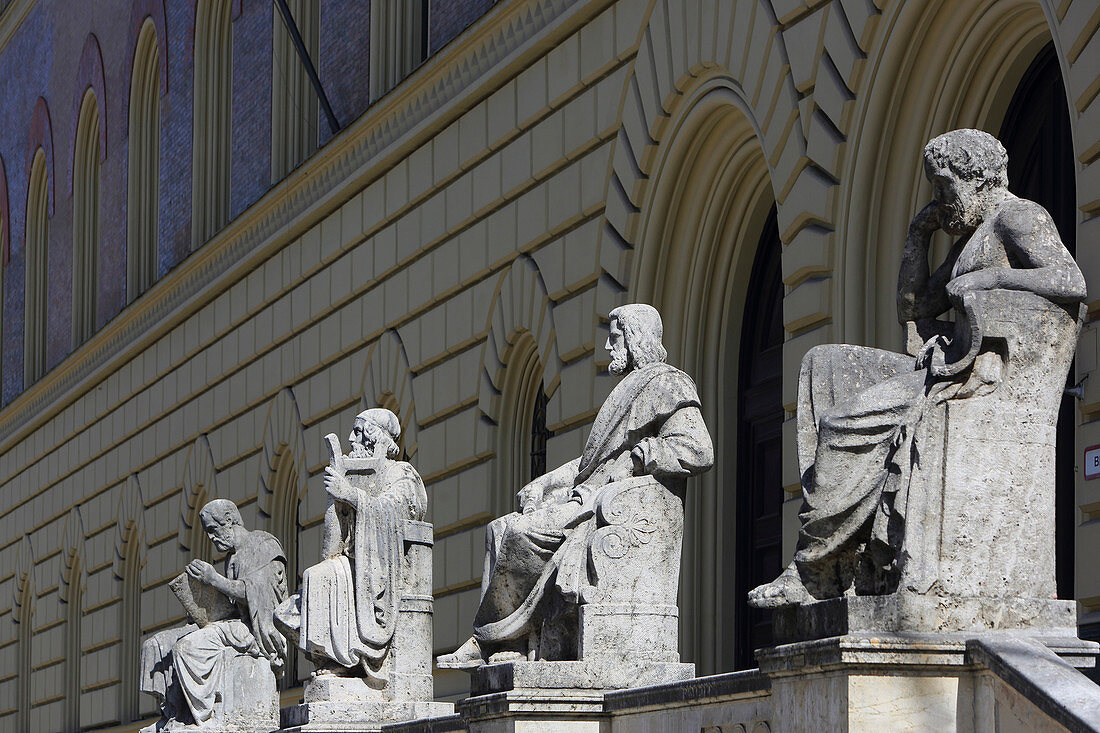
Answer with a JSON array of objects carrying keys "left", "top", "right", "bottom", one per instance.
[{"left": 471, "top": 658, "right": 695, "bottom": 697}]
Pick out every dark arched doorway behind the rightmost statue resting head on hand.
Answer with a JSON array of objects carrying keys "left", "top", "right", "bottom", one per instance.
[{"left": 999, "top": 43, "right": 1082, "bottom": 635}]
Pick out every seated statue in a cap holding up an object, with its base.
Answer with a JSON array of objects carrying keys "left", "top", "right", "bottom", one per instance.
[{"left": 275, "top": 408, "right": 453, "bottom": 730}]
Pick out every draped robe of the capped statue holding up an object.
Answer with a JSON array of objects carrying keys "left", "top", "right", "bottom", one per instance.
[{"left": 294, "top": 459, "right": 428, "bottom": 672}]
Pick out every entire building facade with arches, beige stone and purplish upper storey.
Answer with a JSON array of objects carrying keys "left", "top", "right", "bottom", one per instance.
[{"left": 0, "top": 0, "right": 1100, "bottom": 731}]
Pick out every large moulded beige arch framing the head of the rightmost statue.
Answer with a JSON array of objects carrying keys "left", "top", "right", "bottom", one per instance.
[{"left": 833, "top": 0, "right": 1052, "bottom": 349}]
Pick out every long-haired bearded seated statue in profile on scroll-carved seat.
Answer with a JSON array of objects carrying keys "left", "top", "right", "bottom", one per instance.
[{"left": 438, "top": 304, "right": 714, "bottom": 669}]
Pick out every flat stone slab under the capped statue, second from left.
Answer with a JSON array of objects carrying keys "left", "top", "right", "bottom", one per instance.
[{"left": 282, "top": 700, "right": 454, "bottom": 733}]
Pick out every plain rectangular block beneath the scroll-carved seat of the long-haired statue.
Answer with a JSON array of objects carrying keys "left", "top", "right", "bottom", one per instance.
[{"left": 580, "top": 603, "right": 680, "bottom": 663}]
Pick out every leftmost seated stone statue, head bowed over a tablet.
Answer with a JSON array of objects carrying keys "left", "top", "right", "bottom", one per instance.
[{"left": 141, "top": 499, "right": 286, "bottom": 731}]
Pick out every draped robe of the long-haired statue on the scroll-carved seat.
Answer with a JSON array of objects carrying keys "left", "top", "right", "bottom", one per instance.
[{"left": 474, "top": 362, "right": 713, "bottom": 645}]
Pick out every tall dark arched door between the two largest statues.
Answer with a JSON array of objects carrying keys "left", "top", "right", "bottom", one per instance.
[{"left": 735, "top": 206, "right": 783, "bottom": 669}]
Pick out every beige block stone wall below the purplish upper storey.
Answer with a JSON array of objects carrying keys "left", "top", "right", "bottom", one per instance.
[{"left": 0, "top": 0, "right": 1100, "bottom": 730}]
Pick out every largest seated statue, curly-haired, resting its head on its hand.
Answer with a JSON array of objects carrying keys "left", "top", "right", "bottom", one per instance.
[{"left": 749, "top": 130, "right": 1086, "bottom": 611}]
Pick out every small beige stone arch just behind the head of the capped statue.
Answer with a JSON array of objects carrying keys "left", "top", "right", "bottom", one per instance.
[{"left": 360, "top": 330, "right": 418, "bottom": 458}]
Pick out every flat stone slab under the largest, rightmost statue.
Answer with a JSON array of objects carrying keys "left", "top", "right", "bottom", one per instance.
[{"left": 773, "top": 592, "right": 1077, "bottom": 644}]
